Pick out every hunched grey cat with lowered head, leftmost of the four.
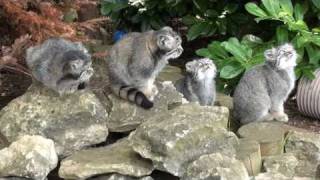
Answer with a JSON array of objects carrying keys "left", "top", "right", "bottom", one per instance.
[{"left": 26, "top": 38, "right": 93, "bottom": 95}]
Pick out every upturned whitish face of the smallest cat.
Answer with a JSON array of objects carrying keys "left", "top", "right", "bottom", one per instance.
[{"left": 186, "top": 58, "right": 217, "bottom": 80}]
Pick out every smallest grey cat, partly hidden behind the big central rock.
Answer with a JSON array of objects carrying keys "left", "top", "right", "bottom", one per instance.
[{"left": 175, "top": 58, "right": 217, "bottom": 106}]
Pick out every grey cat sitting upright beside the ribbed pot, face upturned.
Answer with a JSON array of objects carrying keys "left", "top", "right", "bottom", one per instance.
[{"left": 233, "top": 44, "right": 297, "bottom": 124}]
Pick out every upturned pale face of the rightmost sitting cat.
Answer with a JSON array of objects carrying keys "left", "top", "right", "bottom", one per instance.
[{"left": 265, "top": 44, "right": 298, "bottom": 70}]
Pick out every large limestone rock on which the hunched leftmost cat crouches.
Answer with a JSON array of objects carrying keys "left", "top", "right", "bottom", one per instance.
[{"left": 0, "top": 84, "right": 108, "bottom": 155}]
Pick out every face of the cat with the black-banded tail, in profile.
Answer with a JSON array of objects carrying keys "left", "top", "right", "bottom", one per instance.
[{"left": 157, "top": 27, "right": 183, "bottom": 58}]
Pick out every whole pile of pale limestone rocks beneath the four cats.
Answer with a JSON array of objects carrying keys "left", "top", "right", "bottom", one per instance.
[{"left": 0, "top": 64, "right": 320, "bottom": 180}]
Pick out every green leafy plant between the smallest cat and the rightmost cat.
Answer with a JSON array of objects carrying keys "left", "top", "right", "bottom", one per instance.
[{"left": 196, "top": 35, "right": 271, "bottom": 93}]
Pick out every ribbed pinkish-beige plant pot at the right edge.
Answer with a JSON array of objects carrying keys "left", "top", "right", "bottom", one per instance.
[{"left": 297, "top": 69, "right": 320, "bottom": 119}]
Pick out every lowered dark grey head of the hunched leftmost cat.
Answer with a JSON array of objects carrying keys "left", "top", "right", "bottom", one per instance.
[{"left": 62, "top": 50, "right": 92, "bottom": 75}]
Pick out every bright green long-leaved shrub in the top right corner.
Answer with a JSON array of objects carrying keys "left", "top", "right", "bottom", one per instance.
[{"left": 245, "top": 0, "right": 320, "bottom": 79}]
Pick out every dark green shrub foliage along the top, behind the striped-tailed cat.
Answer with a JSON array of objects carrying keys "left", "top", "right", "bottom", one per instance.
[{"left": 101, "top": 0, "right": 248, "bottom": 40}]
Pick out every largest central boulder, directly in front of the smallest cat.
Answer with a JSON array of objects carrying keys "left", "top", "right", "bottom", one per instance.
[{"left": 129, "top": 103, "right": 238, "bottom": 176}]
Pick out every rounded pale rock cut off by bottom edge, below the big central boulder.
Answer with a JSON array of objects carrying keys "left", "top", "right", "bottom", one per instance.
[{"left": 182, "top": 153, "right": 249, "bottom": 180}]
